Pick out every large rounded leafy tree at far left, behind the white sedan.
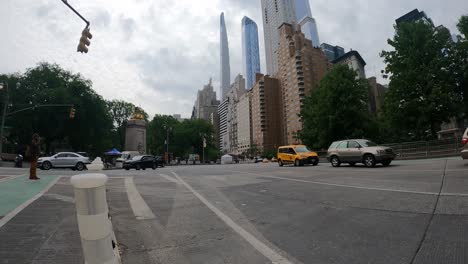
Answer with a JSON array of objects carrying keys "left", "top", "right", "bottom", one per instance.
[{"left": 5, "top": 63, "right": 112, "bottom": 155}]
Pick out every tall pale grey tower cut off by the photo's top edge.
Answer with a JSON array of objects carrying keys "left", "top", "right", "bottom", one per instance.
[{"left": 261, "top": 0, "right": 297, "bottom": 75}]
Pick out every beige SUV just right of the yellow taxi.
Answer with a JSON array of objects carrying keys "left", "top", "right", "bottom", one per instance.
[{"left": 327, "top": 139, "right": 396, "bottom": 167}]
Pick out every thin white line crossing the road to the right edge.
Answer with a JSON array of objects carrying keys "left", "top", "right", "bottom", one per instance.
[{"left": 233, "top": 171, "right": 468, "bottom": 197}]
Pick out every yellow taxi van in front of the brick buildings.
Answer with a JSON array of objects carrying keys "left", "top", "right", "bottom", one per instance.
[{"left": 277, "top": 145, "right": 319, "bottom": 167}]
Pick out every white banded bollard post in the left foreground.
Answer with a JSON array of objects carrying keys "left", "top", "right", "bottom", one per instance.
[{"left": 70, "top": 173, "right": 120, "bottom": 264}]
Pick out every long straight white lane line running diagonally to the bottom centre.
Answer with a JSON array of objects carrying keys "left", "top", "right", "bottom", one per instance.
[{"left": 171, "top": 171, "right": 292, "bottom": 264}]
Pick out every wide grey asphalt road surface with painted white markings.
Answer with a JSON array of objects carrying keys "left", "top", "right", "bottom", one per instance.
[{"left": 0, "top": 160, "right": 468, "bottom": 264}]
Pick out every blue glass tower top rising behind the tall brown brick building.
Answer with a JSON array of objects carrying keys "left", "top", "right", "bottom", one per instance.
[{"left": 295, "top": 0, "right": 320, "bottom": 47}]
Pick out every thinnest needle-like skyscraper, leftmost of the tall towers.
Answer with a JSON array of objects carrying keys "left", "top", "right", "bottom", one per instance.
[{"left": 219, "top": 13, "right": 231, "bottom": 101}]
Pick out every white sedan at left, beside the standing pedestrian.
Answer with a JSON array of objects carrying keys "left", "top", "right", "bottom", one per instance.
[{"left": 37, "top": 152, "right": 91, "bottom": 171}]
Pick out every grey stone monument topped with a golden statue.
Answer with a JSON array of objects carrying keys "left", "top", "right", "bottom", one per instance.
[{"left": 125, "top": 107, "right": 146, "bottom": 154}]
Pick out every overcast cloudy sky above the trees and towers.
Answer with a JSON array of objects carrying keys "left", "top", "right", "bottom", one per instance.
[{"left": 0, "top": 0, "right": 468, "bottom": 117}]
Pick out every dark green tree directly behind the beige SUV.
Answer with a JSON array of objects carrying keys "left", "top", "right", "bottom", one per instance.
[{"left": 297, "top": 65, "right": 376, "bottom": 149}]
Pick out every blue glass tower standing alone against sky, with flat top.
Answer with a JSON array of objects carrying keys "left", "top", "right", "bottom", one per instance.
[{"left": 242, "top": 16, "right": 260, "bottom": 90}]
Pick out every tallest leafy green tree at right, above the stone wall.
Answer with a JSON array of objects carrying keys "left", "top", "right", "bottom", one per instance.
[{"left": 381, "top": 22, "right": 461, "bottom": 140}]
